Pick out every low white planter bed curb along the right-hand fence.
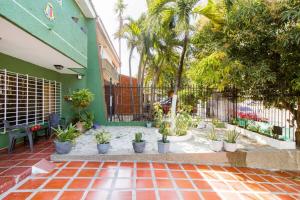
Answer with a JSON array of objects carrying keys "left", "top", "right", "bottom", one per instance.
[{"left": 227, "top": 124, "right": 296, "bottom": 149}]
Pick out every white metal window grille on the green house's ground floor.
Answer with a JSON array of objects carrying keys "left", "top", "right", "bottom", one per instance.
[{"left": 0, "top": 69, "right": 61, "bottom": 131}]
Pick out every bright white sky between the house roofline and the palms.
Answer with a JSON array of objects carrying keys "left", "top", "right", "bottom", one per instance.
[{"left": 92, "top": 0, "right": 147, "bottom": 76}]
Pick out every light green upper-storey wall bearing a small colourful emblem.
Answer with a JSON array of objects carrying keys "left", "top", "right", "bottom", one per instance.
[{"left": 0, "top": 0, "right": 87, "bottom": 67}]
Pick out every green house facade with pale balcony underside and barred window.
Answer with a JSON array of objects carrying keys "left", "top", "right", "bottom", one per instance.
[{"left": 0, "top": 0, "right": 120, "bottom": 149}]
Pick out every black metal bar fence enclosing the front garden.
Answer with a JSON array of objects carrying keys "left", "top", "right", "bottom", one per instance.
[{"left": 105, "top": 85, "right": 296, "bottom": 141}]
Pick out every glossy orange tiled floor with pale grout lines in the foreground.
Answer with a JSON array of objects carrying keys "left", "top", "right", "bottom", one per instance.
[{"left": 0, "top": 161, "right": 300, "bottom": 200}]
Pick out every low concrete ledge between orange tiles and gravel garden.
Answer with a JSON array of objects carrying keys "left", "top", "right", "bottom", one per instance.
[{"left": 51, "top": 150, "right": 300, "bottom": 171}]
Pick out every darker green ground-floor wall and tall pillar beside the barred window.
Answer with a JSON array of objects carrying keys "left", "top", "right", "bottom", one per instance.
[{"left": 0, "top": 19, "right": 106, "bottom": 149}]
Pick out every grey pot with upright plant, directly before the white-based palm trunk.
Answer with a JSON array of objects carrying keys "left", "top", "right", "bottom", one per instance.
[{"left": 157, "top": 121, "right": 170, "bottom": 153}]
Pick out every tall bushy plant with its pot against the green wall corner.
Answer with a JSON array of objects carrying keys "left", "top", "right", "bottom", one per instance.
[{"left": 71, "top": 89, "right": 94, "bottom": 133}]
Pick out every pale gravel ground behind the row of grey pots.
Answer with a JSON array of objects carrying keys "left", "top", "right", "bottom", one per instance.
[{"left": 69, "top": 124, "right": 273, "bottom": 155}]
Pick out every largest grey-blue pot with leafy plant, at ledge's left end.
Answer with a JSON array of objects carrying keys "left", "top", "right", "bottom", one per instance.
[{"left": 52, "top": 124, "right": 79, "bottom": 154}]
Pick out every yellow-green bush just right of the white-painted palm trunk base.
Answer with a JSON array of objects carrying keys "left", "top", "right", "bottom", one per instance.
[{"left": 175, "top": 110, "right": 192, "bottom": 136}]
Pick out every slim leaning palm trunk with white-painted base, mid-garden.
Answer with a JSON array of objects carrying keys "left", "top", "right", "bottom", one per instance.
[{"left": 171, "top": 32, "right": 189, "bottom": 132}]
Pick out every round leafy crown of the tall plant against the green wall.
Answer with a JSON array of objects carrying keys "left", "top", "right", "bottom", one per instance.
[{"left": 71, "top": 89, "right": 94, "bottom": 110}]
